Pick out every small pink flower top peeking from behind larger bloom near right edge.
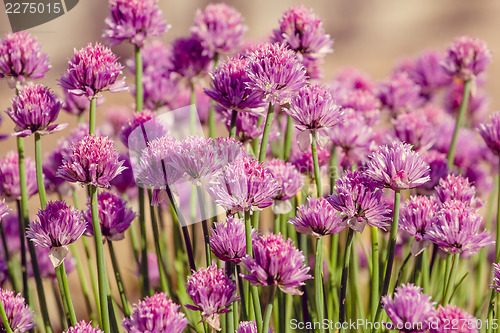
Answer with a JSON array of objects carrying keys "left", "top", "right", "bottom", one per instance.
[{"left": 435, "top": 174, "right": 483, "bottom": 208}]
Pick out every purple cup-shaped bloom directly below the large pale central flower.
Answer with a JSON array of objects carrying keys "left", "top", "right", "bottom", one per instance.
[{"left": 210, "top": 216, "right": 257, "bottom": 263}]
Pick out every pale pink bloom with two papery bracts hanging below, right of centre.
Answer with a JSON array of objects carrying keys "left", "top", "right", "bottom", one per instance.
[{"left": 284, "top": 84, "right": 343, "bottom": 150}]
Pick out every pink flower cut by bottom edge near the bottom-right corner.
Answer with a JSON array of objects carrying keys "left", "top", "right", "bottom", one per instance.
[{"left": 429, "top": 304, "right": 480, "bottom": 333}]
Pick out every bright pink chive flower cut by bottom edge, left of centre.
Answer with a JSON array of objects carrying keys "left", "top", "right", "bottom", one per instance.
[{"left": 122, "top": 293, "right": 189, "bottom": 333}]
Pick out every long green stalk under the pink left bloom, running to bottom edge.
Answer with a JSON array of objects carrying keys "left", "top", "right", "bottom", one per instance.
[{"left": 90, "top": 185, "right": 111, "bottom": 333}]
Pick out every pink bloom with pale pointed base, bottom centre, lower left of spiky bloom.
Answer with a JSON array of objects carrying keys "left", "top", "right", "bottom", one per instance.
[{"left": 185, "top": 265, "right": 238, "bottom": 331}]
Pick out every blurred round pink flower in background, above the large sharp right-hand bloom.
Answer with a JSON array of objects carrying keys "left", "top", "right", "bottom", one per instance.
[{"left": 377, "top": 72, "right": 424, "bottom": 116}]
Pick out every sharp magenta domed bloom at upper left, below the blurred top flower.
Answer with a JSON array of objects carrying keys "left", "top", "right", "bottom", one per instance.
[{"left": 59, "top": 43, "right": 128, "bottom": 99}]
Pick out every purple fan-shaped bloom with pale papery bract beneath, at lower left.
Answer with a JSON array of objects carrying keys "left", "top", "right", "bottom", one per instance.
[{"left": 26, "top": 201, "right": 87, "bottom": 267}]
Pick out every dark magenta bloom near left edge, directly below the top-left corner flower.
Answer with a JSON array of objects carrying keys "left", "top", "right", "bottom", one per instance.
[{"left": 5, "top": 84, "right": 68, "bottom": 137}]
